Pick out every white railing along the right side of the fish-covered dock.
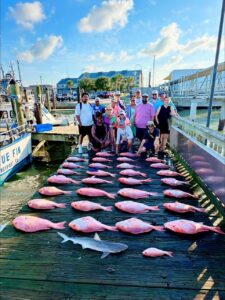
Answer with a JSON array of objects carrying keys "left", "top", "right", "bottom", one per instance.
[{"left": 172, "top": 117, "right": 225, "bottom": 158}]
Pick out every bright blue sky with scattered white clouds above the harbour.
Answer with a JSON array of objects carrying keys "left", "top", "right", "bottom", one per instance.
[{"left": 0, "top": 0, "right": 225, "bottom": 85}]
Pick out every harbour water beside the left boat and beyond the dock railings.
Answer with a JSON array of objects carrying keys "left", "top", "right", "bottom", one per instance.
[{"left": 0, "top": 109, "right": 220, "bottom": 223}]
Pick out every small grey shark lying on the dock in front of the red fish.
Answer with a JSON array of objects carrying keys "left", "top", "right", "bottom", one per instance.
[{"left": 58, "top": 232, "right": 128, "bottom": 258}]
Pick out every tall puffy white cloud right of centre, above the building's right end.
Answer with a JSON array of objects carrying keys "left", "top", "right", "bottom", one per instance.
[{"left": 141, "top": 22, "right": 181, "bottom": 58}]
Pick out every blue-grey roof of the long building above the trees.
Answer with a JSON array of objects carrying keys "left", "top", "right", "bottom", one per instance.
[{"left": 78, "top": 70, "right": 143, "bottom": 87}]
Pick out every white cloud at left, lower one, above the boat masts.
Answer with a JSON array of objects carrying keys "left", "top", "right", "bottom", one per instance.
[{"left": 18, "top": 35, "right": 63, "bottom": 63}]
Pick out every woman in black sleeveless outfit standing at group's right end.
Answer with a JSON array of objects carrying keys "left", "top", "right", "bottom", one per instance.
[{"left": 156, "top": 97, "right": 176, "bottom": 151}]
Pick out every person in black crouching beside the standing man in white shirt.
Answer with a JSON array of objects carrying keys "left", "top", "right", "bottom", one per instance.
[{"left": 91, "top": 112, "right": 110, "bottom": 152}]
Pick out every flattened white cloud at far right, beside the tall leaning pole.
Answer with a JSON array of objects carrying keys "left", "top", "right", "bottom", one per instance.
[{"left": 180, "top": 35, "right": 217, "bottom": 55}]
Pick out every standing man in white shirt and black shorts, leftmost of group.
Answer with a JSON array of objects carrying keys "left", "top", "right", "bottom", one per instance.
[{"left": 75, "top": 92, "right": 94, "bottom": 154}]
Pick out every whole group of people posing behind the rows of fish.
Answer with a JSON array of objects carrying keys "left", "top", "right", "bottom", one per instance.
[{"left": 75, "top": 89, "right": 177, "bottom": 154}]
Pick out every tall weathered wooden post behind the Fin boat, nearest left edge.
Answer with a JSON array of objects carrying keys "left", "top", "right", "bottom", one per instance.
[{"left": 10, "top": 79, "right": 25, "bottom": 126}]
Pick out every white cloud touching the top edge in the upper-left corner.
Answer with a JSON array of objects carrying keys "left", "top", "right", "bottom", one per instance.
[{"left": 9, "top": 1, "right": 46, "bottom": 29}]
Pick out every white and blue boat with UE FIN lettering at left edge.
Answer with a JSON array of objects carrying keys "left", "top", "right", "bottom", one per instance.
[{"left": 0, "top": 126, "right": 32, "bottom": 185}]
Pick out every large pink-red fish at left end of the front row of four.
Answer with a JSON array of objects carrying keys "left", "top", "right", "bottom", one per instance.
[{"left": 12, "top": 216, "right": 66, "bottom": 232}]
